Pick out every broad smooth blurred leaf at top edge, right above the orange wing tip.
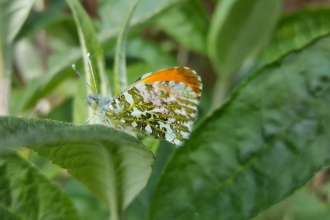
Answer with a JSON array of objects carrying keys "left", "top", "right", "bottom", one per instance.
[{"left": 208, "top": 0, "right": 282, "bottom": 80}]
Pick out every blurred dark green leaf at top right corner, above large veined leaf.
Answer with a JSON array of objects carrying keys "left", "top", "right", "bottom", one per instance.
[{"left": 260, "top": 8, "right": 330, "bottom": 63}]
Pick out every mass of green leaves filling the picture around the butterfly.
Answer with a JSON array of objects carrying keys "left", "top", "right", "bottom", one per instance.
[{"left": 0, "top": 0, "right": 330, "bottom": 220}]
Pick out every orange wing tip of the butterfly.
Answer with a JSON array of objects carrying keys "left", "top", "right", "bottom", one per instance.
[{"left": 142, "top": 67, "right": 202, "bottom": 97}]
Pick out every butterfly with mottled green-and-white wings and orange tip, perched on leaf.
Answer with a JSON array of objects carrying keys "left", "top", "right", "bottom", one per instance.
[{"left": 74, "top": 54, "right": 202, "bottom": 146}]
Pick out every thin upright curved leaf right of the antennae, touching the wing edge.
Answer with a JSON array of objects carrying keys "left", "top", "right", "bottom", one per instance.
[{"left": 114, "top": 0, "right": 140, "bottom": 96}]
